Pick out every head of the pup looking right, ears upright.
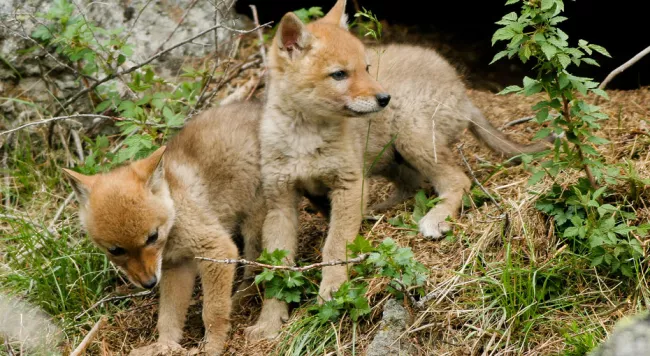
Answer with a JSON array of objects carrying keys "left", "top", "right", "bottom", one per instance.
[{"left": 270, "top": 0, "right": 387, "bottom": 117}]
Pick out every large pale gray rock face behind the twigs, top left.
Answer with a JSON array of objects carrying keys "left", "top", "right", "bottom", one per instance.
[{"left": 0, "top": 0, "right": 251, "bottom": 121}]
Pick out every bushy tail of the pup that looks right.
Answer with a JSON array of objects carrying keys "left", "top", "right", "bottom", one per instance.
[{"left": 470, "top": 105, "right": 556, "bottom": 157}]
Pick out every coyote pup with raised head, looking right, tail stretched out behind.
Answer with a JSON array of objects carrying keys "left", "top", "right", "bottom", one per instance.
[{"left": 247, "top": 0, "right": 545, "bottom": 338}]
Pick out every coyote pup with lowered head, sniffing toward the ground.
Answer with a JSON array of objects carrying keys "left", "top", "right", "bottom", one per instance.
[{"left": 65, "top": 103, "right": 264, "bottom": 354}]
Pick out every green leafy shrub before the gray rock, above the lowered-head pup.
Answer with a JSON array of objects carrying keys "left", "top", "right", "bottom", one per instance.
[{"left": 32, "top": 0, "right": 211, "bottom": 168}]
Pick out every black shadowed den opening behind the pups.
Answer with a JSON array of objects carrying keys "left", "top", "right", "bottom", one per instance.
[{"left": 236, "top": 0, "right": 650, "bottom": 90}]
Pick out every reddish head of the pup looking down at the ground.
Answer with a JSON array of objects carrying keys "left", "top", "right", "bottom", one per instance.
[{"left": 64, "top": 147, "right": 174, "bottom": 286}]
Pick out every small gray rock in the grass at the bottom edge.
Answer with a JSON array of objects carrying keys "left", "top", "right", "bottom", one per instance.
[{"left": 366, "top": 299, "right": 415, "bottom": 356}]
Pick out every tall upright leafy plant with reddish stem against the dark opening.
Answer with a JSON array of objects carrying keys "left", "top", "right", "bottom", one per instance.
[{"left": 492, "top": 0, "right": 610, "bottom": 190}]
